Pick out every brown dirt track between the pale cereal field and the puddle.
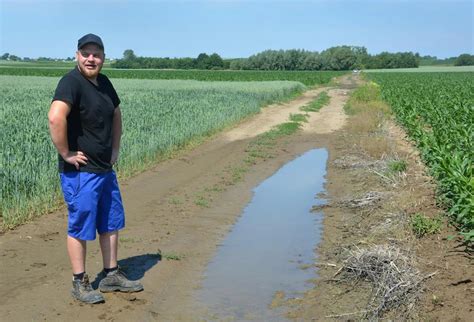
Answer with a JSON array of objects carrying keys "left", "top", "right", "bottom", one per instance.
[{"left": 0, "top": 77, "right": 353, "bottom": 321}]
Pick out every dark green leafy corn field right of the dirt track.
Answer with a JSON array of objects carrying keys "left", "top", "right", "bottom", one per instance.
[{"left": 369, "top": 73, "right": 474, "bottom": 239}]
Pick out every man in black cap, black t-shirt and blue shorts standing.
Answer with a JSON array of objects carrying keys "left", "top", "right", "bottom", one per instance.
[{"left": 48, "top": 34, "right": 143, "bottom": 303}]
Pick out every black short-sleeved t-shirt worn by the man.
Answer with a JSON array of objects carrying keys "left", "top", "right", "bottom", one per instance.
[{"left": 53, "top": 67, "right": 120, "bottom": 173}]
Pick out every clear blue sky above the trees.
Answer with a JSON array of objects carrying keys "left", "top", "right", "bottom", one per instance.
[{"left": 0, "top": 0, "right": 474, "bottom": 58}]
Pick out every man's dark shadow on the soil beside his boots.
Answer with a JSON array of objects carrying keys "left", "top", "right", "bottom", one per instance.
[{"left": 92, "top": 253, "right": 161, "bottom": 289}]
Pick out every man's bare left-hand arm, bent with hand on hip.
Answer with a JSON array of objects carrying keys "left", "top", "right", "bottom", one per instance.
[{"left": 48, "top": 101, "right": 87, "bottom": 170}]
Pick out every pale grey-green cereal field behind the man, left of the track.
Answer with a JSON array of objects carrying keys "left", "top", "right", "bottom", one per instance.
[{"left": 0, "top": 76, "right": 304, "bottom": 227}]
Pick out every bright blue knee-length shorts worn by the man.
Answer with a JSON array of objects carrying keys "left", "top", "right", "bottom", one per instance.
[{"left": 60, "top": 171, "right": 125, "bottom": 240}]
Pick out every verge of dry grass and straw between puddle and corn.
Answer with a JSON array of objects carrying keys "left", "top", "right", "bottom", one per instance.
[{"left": 316, "top": 80, "right": 448, "bottom": 321}]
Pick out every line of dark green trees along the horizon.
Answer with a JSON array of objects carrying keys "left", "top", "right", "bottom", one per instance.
[{"left": 0, "top": 46, "right": 474, "bottom": 71}]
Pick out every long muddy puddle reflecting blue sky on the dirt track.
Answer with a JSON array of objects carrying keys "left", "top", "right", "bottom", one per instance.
[{"left": 197, "top": 149, "right": 328, "bottom": 321}]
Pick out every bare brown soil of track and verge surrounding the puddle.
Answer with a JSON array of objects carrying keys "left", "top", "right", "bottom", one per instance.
[{"left": 0, "top": 76, "right": 474, "bottom": 321}]
